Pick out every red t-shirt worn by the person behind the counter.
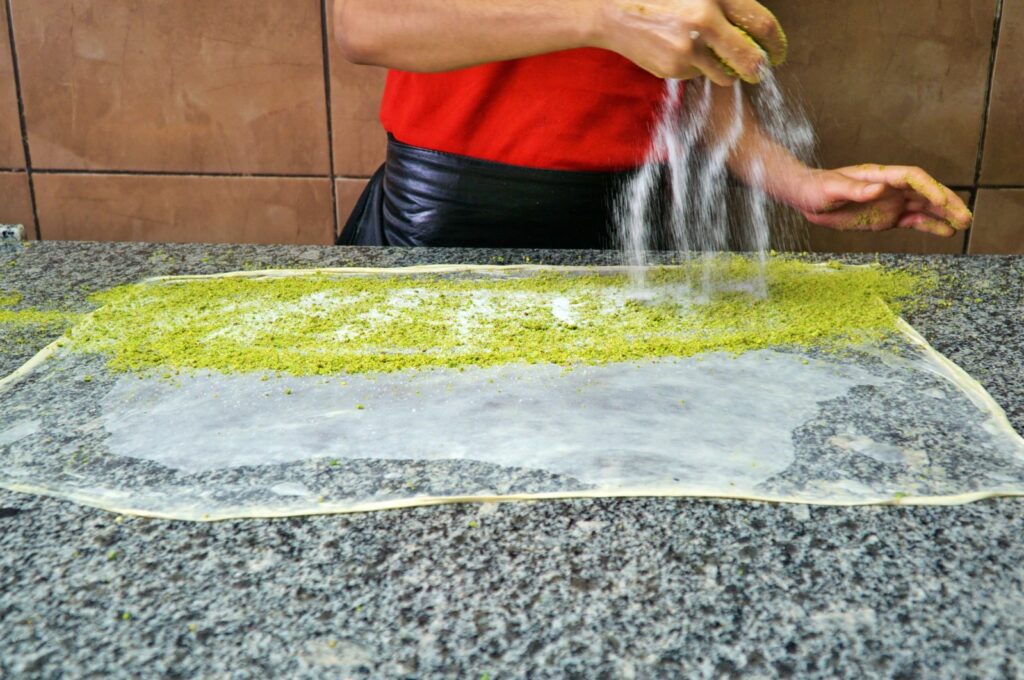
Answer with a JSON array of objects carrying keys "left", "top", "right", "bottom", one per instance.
[{"left": 381, "top": 48, "right": 682, "bottom": 171}]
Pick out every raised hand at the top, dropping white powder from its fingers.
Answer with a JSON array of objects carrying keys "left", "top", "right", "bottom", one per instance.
[{"left": 596, "top": 0, "right": 786, "bottom": 85}]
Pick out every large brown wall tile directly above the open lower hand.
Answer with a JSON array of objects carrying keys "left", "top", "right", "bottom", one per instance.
[{"left": 768, "top": 0, "right": 996, "bottom": 186}]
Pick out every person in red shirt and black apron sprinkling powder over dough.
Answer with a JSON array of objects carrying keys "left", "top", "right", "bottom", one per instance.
[{"left": 334, "top": 0, "right": 972, "bottom": 248}]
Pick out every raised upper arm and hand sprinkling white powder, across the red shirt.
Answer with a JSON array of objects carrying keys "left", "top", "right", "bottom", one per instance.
[{"left": 334, "top": 0, "right": 785, "bottom": 85}]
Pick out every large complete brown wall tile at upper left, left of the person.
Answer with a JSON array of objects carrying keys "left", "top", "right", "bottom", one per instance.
[{"left": 12, "top": 0, "right": 329, "bottom": 175}]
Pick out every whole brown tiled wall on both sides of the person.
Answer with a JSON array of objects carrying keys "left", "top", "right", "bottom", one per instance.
[{"left": 0, "top": 0, "right": 1024, "bottom": 253}]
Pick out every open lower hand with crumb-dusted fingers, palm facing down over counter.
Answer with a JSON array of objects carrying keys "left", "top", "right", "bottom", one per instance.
[{"left": 781, "top": 165, "right": 972, "bottom": 237}]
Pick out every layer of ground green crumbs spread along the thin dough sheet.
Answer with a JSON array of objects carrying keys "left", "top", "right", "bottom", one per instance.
[{"left": 59, "top": 256, "right": 932, "bottom": 375}]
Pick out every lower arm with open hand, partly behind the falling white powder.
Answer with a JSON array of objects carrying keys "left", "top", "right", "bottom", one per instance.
[{"left": 710, "top": 83, "right": 972, "bottom": 237}]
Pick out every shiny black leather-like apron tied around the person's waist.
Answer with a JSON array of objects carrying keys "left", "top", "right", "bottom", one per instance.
[{"left": 338, "top": 134, "right": 667, "bottom": 248}]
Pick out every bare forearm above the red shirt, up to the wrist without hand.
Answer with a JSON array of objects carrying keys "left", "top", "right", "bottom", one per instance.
[{"left": 334, "top": 0, "right": 599, "bottom": 72}]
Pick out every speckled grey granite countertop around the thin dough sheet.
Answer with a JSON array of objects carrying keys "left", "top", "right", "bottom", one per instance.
[{"left": 0, "top": 242, "right": 1024, "bottom": 679}]
